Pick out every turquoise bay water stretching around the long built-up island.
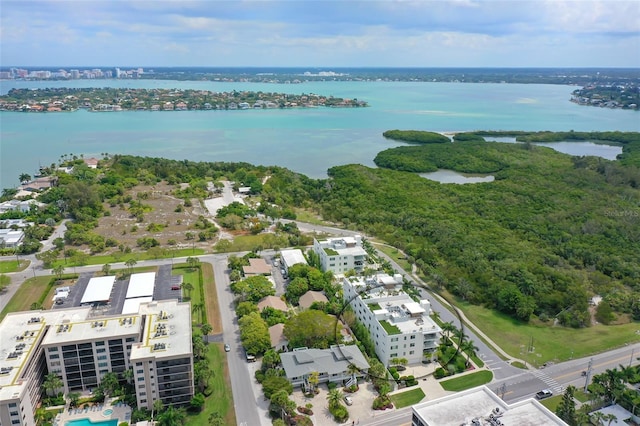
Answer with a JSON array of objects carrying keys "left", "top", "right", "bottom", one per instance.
[{"left": 0, "top": 80, "right": 640, "bottom": 188}]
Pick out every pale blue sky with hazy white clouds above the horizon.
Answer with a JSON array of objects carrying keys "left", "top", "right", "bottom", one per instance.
[{"left": 0, "top": 0, "right": 640, "bottom": 67}]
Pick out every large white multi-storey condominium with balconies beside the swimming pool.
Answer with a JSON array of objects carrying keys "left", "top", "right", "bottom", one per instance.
[{"left": 0, "top": 300, "right": 194, "bottom": 425}]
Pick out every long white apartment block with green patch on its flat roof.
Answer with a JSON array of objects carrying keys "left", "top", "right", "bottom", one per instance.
[{"left": 342, "top": 274, "right": 442, "bottom": 365}]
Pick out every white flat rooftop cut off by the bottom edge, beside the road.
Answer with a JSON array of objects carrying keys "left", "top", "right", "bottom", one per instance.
[{"left": 411, "top": 386, "right": 567, "bottom": 426}]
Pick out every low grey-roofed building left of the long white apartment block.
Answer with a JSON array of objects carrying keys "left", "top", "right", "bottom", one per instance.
[{"left": 280, "top": 345, "right": 369, "bottom": 387}]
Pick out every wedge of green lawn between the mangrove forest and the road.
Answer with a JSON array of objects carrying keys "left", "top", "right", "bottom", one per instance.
[{"left": 457, "top": 301, "right": 640, "bottom": 366}]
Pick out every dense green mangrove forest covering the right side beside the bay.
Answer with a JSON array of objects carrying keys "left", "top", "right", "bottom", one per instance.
[{"left": 320, "top": 134, "right": 640, "bottom": 326}]
